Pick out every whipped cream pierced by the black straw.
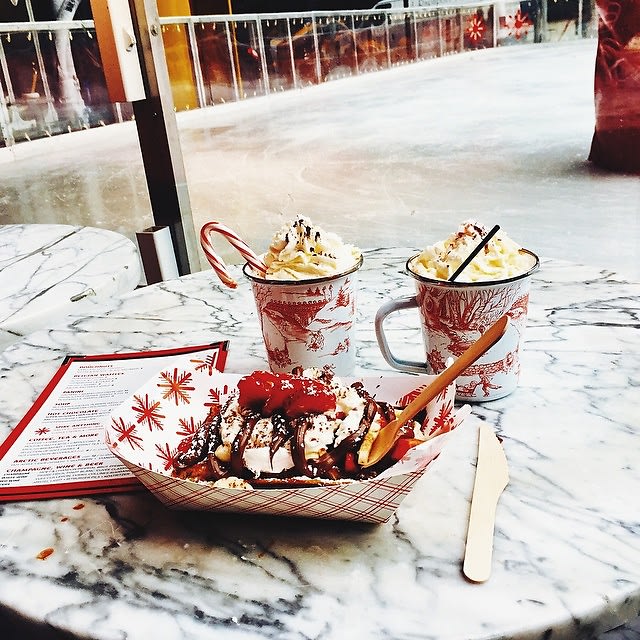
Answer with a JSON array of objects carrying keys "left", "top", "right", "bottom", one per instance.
[{"left": 409, "top": 220, "right": 535, "bottom": 282}]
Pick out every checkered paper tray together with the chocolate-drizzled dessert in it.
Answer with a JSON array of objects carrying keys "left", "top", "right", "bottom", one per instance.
[{"left": 105, "top": 357, "right": 470, "bottom": 523}]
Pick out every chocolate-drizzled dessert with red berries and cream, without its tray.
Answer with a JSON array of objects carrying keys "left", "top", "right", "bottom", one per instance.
[{"left": 173, "top": 369, "right": 453, "bottom": 488}]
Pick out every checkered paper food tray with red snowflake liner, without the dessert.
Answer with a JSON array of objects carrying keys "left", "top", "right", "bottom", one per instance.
[{"left": 105, "top": 368, "right": 470, "bottom": 523}]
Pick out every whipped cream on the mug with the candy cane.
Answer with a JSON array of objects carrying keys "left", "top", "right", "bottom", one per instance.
[{"left": 263, "top": 216, "right": 362, "bottom": 280}]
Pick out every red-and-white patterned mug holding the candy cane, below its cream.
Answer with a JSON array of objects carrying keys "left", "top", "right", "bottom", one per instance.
[{"left": 243, "top": 257, "right": 362, "bottom": 375}]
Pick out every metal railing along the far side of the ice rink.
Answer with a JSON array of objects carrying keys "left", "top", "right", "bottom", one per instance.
[{"left": 0, "top": 0, "right": 597, "bottom": 146}]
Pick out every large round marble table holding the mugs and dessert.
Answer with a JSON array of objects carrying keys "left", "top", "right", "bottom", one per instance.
[{"left": 0, "top": 249, "right": 640, "bottom": 640}]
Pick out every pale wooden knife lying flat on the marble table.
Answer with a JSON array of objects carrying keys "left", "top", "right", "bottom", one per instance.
[{"left": 462, "top": 423, "right": 509, "bottom": 582}]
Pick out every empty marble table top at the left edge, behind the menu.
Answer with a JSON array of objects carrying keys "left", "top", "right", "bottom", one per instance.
[{"left": 0, "top": 224, "right": 141, "bottom": 348}]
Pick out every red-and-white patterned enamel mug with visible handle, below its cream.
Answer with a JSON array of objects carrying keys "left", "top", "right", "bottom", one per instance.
[{"left": 375, "top": 250, "right": 540, "bottom": 402}]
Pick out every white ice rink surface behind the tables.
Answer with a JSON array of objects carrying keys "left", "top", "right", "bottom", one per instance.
[{"left": 0, "top": 40, "right": 640, "bottom": 279}]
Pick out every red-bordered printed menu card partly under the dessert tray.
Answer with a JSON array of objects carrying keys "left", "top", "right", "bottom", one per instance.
[{"left": 0, "top": 341, "right": 229, "bottom": 502}]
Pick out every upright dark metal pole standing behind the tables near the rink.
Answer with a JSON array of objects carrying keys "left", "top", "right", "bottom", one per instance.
[{"left": 129, "top": 0, "right": 200, "bottom": 275}]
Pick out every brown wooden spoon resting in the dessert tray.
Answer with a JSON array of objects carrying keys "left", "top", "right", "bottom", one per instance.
[{"left": 361, "top": 315, "right": 509, "bottom": 467}]
